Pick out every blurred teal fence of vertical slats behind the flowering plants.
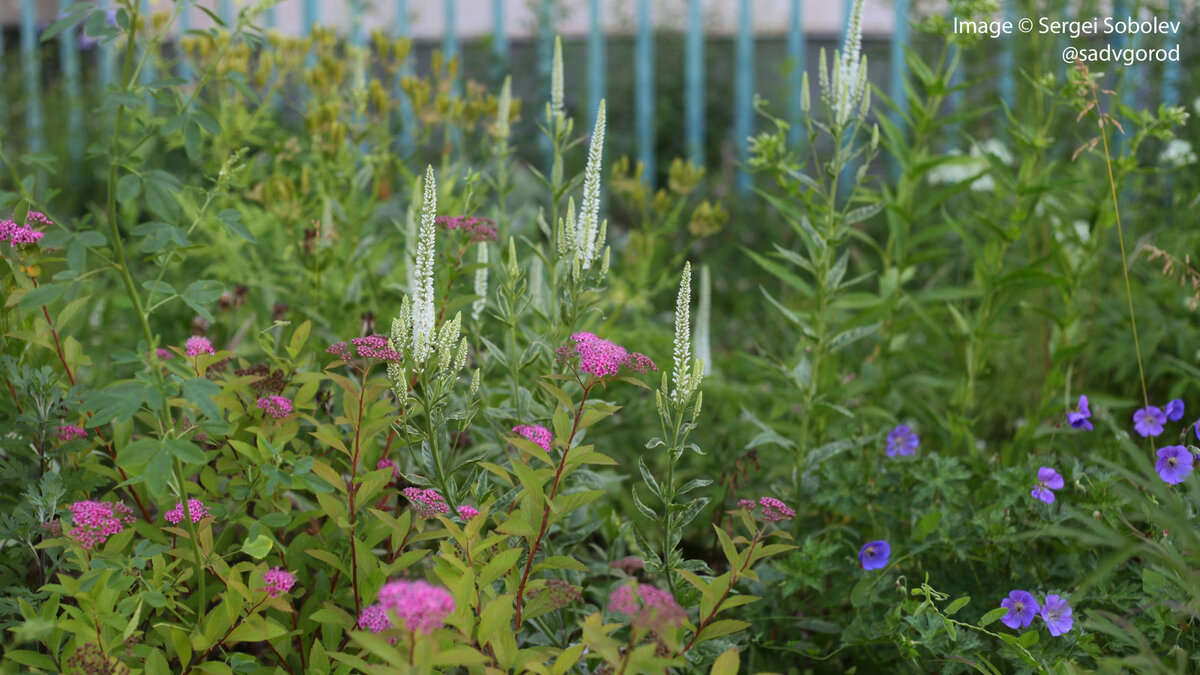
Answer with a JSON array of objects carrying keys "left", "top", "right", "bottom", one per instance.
[{"left": 0, "top": 0, "right": 1181, "bottom": 191}]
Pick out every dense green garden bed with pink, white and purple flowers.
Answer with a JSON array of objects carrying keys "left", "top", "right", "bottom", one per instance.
[{"left": 0, "top": 1, "right": 1200, "bottom": 674}]
